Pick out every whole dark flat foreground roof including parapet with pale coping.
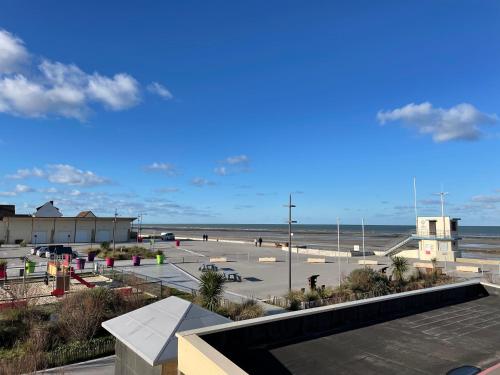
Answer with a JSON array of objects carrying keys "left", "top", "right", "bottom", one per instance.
[{"left": 189, "top": 280, "right": 500, "bottom": 375}]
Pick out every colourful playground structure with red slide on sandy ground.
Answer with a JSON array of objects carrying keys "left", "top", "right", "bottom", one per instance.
[{"left": 46, "top": 254, "right": 95, "bottom": 297}]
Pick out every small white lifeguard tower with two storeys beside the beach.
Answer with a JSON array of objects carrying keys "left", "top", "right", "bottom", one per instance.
[{"left": 413, "top": 216, "right": 461, "bottom": 262}]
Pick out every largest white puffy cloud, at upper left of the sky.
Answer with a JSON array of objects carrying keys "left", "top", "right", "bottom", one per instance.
[{"left": 0, "top": 30, "right": 148, "bottom": 121}]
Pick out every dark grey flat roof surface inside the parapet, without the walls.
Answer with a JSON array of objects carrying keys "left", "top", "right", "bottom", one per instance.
[{"left": 224, "top": 295, "right": 500, "bottom": 374}]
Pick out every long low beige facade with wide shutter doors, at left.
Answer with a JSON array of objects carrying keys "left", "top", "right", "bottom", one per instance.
[{"left": 0, "top": 217, "right": 131, "bottom": 244}]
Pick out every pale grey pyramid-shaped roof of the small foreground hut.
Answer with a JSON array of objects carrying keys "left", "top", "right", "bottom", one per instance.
[{"left": 102, "top": 297, "right": 231, "bottom": 366}]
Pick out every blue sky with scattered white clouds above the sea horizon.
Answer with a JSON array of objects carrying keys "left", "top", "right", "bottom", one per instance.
[{"left": 0, "top": 0, "right": 500, "bottom": 225}]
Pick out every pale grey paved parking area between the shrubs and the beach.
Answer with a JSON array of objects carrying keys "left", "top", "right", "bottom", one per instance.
[{"left": 0, "top": 240, "right": 498, "bottom": 299}]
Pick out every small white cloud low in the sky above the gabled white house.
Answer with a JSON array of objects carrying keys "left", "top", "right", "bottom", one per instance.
[{"left": 47, "top": 164, "right": 109, "bottom": 186}]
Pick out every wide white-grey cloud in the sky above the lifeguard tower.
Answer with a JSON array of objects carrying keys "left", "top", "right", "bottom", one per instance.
[{"left": 377, "top": 102, "right": 498, "bottom": 142}]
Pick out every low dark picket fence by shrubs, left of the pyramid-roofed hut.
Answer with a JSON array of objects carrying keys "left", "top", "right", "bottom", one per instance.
[{"left": 46, "top": 336, "right": 115, "bottom": 368}]
